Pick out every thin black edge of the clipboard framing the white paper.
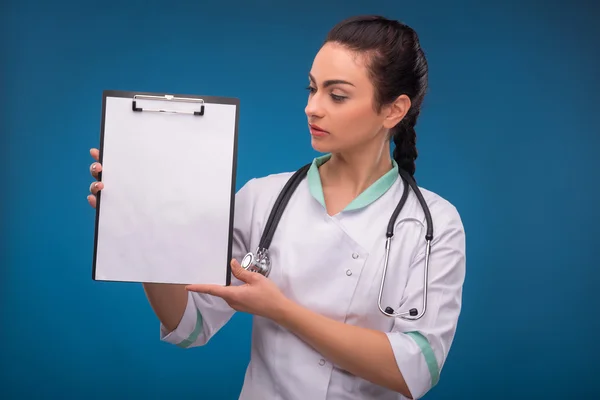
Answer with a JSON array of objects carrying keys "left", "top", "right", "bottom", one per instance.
[{"left": 92, "top": 89, "right": 240, "bottom": 286}]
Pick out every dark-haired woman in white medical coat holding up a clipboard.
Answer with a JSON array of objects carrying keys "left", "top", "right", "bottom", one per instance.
[{"left": 88, "top": 17, "right": 465, "bottom": 400}]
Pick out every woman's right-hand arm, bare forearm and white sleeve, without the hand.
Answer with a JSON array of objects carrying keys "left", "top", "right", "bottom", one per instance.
[{"left": 273, "top": 208, "right": 466, "bottom": 398}]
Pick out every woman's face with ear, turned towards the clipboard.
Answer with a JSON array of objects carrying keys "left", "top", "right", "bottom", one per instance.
[{"left": 305, "top": 43, "right": 406, "bottom": 153}]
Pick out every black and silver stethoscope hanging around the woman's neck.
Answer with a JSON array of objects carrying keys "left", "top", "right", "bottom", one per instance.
[{"left": 241, "top": 164, "right": 433, "bottom": 320}]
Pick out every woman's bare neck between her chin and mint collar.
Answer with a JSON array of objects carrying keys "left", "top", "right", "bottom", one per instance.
[{"left": 319, "top": 142, "right": 393, "bottom": 196}]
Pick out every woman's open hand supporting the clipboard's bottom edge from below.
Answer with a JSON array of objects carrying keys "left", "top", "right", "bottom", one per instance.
[{"left": 186, "top": 260, "right": 287, "bottom": 320}]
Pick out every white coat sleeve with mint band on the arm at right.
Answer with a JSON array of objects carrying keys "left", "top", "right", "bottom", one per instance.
[{"left": 387, "top": 205, "right": 466, "bottom": 399}]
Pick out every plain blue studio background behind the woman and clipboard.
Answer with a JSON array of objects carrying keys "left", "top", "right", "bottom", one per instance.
[{"left": 0, "top": 0, "right": 600, "bottom": 399}]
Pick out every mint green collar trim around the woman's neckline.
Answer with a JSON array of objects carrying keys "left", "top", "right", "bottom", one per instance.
[{"left": 307, "top": 154, "right": 398, "bottom": 211}]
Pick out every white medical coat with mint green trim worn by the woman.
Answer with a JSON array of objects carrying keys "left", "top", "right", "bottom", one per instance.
[{"left": 160, "top": 155, "right": 465, "bottom": 400}]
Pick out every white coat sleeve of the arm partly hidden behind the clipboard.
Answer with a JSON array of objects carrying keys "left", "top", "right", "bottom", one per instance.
[{"left": 160, "top": 179, "right": 255, "bottom": 348}]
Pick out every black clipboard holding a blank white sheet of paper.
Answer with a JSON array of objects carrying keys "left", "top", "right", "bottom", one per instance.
[{"left": 92, "top": 90, "right": 239, "bottom": 285}]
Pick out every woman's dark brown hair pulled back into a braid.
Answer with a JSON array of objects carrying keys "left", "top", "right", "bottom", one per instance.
[{"left": 325, "top": 16, "right": 428, "bottom": 175}]
